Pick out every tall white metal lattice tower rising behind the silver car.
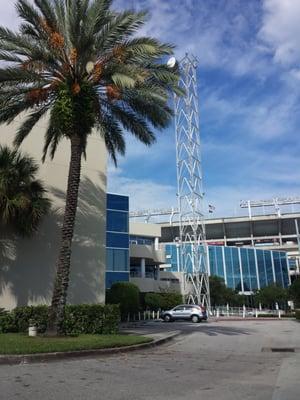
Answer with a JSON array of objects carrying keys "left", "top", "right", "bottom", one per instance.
[{"left": 175, "top": 55, "right": 210, "bottom": 308}]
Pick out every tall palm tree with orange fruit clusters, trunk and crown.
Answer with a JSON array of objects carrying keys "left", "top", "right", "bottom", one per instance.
[{"left": 0, "top": 0, "right": 181, "bottom": 332}]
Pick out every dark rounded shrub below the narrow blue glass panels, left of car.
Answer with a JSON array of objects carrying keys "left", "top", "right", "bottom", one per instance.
[{"left": 107, "top": 282, "right": 140, "bottom": 321}]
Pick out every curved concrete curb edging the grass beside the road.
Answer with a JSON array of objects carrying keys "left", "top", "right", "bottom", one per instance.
[{"left": 0, "top": 332, "right": 180, "bottom": 365}]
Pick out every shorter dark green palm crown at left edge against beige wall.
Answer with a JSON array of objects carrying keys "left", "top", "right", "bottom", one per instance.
[{"left": 0, "top": 146, "right": 50, "bottom": 236}]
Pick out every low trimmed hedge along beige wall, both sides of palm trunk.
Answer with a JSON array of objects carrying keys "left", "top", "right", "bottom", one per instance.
[{"left": 0, "top": 304, "right": 120, "bottom": 335}]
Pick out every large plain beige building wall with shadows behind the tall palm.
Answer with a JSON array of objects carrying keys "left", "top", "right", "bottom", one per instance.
[{"left": 0, "top": 114, "right": 106, "bottom": 309}]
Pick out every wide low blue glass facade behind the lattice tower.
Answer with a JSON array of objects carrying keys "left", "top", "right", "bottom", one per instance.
[{"left": 166, "top": 244, "right": 289, "bottom": 292}]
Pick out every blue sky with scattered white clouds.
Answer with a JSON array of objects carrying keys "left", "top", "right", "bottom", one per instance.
[{"left": 0, "top": 0, "right": 300, "bottom": 219}]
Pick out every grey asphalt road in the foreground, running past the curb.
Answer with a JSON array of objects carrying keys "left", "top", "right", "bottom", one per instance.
[{"left": 0, "top": 320, "right": 300, "bottom": 400}]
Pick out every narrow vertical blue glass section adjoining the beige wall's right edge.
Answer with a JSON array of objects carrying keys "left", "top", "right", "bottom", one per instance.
[{"left": 106, "top": 194, "right": 129, "bottom": 289}]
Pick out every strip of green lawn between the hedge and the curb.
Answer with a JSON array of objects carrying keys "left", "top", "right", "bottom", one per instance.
[{"left": 0, "top": 333, "right": 152, "bottom": 355}]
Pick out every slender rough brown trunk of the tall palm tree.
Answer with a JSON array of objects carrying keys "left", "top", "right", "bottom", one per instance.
[{"left": 47, "top": 135, "right": 82, "bottom": 335}]
